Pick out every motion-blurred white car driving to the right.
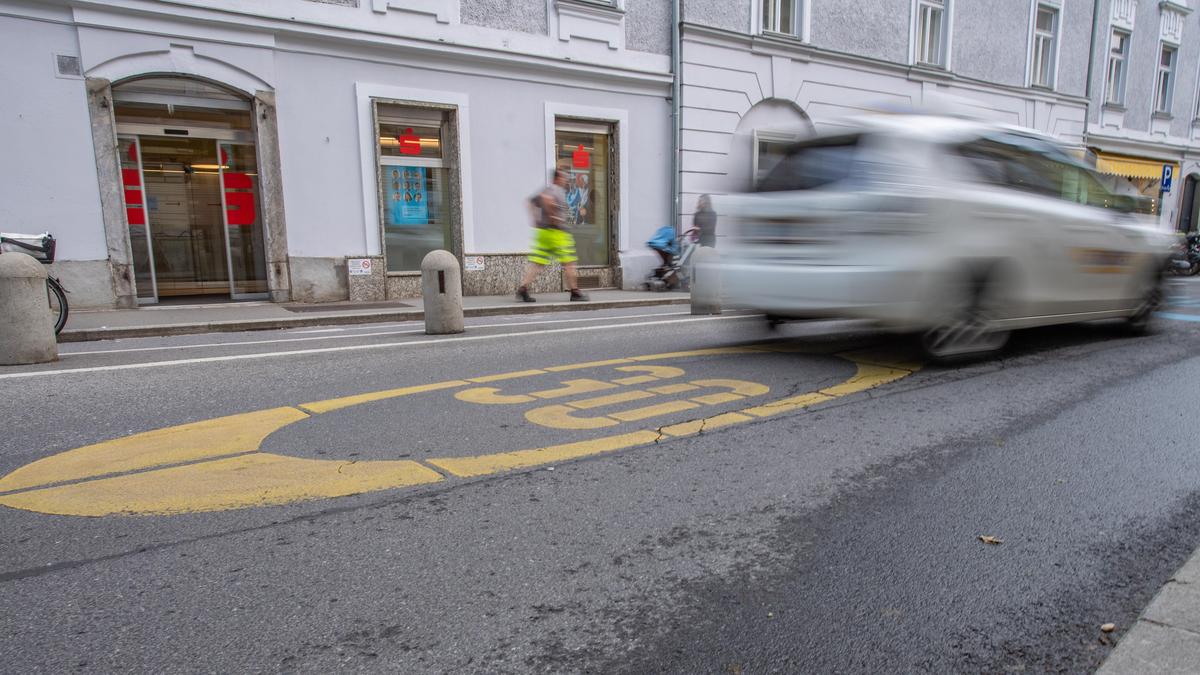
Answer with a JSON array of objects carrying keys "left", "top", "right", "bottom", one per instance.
[{"left": 714, "top": 115, "right": 1170, "bottom": 358}]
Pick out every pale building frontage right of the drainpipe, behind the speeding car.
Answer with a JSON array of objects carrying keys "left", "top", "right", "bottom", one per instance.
[{"left": 680, "top": 0, "right": 1200, "bottom": 229}]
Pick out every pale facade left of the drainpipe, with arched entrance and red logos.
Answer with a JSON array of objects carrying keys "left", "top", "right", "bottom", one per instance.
[{"left": 0, "top": 0, "right": 672, "bottom": 306}]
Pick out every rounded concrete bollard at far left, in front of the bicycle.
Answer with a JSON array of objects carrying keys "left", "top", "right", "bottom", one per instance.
[{"left": 0, "top": 252, "right": 59, "bottom": 365}]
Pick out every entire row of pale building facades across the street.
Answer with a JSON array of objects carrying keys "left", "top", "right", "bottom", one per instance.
[{"left": 0, "top": 0, "right": 1200, "bottom": 307}]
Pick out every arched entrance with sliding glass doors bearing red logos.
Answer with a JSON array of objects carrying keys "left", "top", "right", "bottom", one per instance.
[{"left": 113, "top": 76, "right": 268, "bottom": 304}]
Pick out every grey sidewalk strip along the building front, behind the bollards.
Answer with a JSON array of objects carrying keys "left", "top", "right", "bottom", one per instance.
[{"left": 59, "top": 291, "right": 690, "bottom": 342}]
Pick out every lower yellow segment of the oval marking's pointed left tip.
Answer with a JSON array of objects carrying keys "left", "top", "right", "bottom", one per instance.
[{"left": 0, "top": 453, "right": 443, "bottom": 515}]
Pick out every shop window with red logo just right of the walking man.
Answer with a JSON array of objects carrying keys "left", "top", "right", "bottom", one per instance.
[{"left": 554, "top": 119, "right": 616, "bottom": 265}]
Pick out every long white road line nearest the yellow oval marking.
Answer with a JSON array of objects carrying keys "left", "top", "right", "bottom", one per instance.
[{"left": 7, "top": 315, "right": 757, "bottom": 380}]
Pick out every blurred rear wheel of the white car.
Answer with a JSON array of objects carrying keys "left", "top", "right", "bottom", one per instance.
[{"left": 919, "top": 277, "right": 1012, "bottom": 362}]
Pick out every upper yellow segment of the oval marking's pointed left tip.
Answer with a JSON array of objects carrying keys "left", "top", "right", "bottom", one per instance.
[{"left": 0, "top": 408, "right": 308, "bottom": 492}]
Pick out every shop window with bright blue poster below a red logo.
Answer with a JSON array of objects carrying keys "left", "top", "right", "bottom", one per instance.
[{"left": 376, "top": 103, "right": 456, "bottom": 271}]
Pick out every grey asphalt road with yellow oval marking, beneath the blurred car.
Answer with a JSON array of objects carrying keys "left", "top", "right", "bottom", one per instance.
[{"left": 0, "top": 280, "right": 1200, "bottom": 673}]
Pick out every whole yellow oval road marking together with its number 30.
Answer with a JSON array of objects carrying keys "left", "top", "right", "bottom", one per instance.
[{"left": 0, "top": 346, "right": 919, "bottom": 516}]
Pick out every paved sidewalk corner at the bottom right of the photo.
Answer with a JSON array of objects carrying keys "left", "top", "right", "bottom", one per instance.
[{"left": 1097, "top": 542, "right": 1200, "bottom": 675}]
